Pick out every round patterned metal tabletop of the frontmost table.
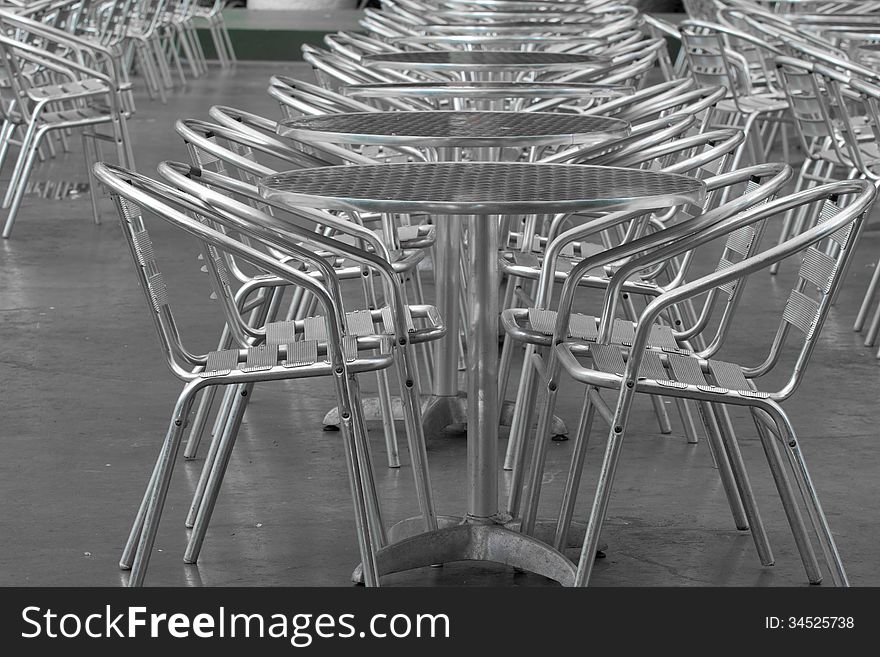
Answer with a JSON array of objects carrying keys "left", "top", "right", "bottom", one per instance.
[{"left": 260, "top": 162, "right": 705, "bottom": 214}]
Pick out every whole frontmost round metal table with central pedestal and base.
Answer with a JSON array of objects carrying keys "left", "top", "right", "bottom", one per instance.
[{"left": 260, "top": 162, "right": 705, "bottom": 585}]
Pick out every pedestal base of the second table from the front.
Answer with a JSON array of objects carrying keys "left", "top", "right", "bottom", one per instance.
[{"left": 324, "top": 392, "right": 568, "bottom": 442}]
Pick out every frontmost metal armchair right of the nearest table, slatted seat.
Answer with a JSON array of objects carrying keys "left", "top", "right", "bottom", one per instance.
[{"left": 552, "top": 180, "right": 876, "bottom": 586}]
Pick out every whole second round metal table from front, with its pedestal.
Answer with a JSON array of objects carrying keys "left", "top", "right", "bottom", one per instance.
[{"left": 278, "top": 111, "right": 629, "bottom": 439}]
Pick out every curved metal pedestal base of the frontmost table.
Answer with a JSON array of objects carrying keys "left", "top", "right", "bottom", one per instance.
[{"left": 351, "top": 516, "right": 607, "bottom": 586}]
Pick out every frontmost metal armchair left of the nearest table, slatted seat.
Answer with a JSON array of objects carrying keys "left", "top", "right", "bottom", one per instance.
[{"left": 95, "top": 163, "right": 416, "bottom": 586}]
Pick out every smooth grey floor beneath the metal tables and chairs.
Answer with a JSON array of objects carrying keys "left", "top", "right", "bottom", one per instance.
[{"left": 0, "top": 63, "right": 880, "bottom": 586}]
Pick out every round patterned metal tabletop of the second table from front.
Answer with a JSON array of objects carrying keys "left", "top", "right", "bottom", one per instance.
[{"left": 277, "top": 110, "right": 629, "bottom": 148}]
